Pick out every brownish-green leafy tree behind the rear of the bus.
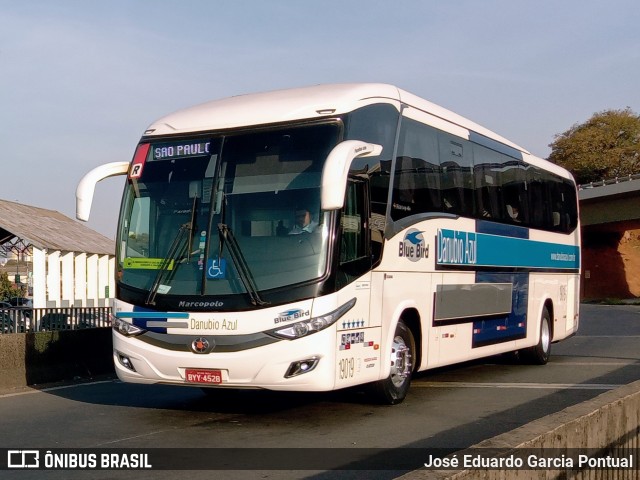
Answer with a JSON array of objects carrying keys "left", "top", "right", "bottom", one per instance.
[{"left": 549, "top": 107, "right": 640, "bottom": 183}]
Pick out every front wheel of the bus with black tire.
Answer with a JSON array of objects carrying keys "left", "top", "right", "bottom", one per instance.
[{"left": 372, "top": 320, "right": 416, "bottom": 405}]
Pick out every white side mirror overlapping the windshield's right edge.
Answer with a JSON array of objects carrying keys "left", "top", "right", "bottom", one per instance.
[{"left": 321, "top": 140, "right": 382, "bottom": 210}]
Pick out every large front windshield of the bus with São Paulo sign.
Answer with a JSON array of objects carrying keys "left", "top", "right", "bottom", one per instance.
[{"left": 117, "top": 122, "right": 341, "bottom": 304}]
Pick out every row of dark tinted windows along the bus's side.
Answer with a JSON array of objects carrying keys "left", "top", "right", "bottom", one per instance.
[{"left": 345, "top": 104, "right": 578, "bottom": 234}]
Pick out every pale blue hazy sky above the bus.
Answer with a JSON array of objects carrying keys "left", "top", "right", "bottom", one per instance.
[{"left": 0, "top": 0, "right": 640, "bottom": 238}]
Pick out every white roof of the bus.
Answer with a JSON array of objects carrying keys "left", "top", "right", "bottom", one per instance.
[{"left": 145, "top": 83, "right": 529, "bottom": 153}]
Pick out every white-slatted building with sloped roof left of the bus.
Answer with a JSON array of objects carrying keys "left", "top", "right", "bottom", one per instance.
[{"left": 0, "top": 200, "right": 115, "bottom": 308}]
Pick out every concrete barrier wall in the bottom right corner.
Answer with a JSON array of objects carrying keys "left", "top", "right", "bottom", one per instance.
[{"left": 400, "top": 381, "right": 640, "bottom": 480}]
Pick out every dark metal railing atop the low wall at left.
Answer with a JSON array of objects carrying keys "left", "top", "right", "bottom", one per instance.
[{"left": 0, "top": 307, "right": 111, "bottom": 334}]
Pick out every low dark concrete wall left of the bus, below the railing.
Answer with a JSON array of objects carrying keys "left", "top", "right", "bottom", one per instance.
[{"left": 0, "top": 328, "right": 114, "bottom": 390}]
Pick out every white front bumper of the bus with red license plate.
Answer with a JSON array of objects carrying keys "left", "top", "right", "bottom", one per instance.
[{"left": 113, "top": 327, "right": 336, "bottom": 391}]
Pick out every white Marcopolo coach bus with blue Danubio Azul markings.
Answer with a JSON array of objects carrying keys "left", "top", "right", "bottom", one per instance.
[{"left": 77, "top": 84, "right": 580, "bottom": 404}]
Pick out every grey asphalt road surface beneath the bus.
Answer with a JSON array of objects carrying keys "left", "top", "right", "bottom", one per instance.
[{"left": 0, "top": 305, "right": 640, "bottom": 480}]
